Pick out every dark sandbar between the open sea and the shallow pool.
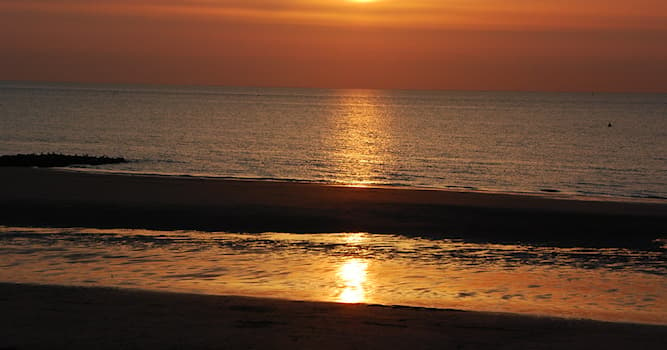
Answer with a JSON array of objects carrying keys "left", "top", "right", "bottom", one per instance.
[{"left": 0, "top": 168, "right": 667, "bottom": 248}]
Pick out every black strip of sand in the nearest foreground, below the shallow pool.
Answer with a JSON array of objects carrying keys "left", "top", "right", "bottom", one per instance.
[{"left": 0, "top": 283, "right": 667, "bottom": 350}]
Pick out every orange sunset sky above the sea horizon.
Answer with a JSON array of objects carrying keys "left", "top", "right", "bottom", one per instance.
[{"left": 0, "top": 0, "right": 667, "bottom": 92}]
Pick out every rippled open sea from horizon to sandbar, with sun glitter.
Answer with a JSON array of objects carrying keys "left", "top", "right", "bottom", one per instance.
[{"left": 0, "top": 82, "right": 667, "bottom": 200}]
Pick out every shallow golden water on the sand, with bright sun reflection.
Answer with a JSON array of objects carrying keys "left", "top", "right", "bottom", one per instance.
[{"left": 0, "top": 226, "right": 667, "bottom": 324}]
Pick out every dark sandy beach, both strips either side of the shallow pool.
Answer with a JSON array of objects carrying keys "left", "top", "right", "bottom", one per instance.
[{"left": 0, "top": 168, "right": 667, "bottom": 349}]
